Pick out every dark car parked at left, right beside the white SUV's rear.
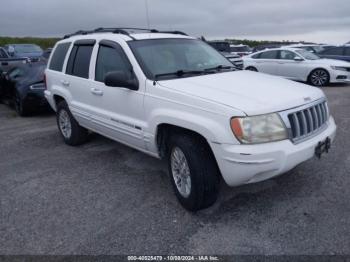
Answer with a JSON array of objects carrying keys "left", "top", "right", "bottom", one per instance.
[{"left": 0, "top": 63, "right": 48, "bottom": 116}]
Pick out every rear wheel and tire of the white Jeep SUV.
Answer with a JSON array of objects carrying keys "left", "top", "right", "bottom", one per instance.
[{"left": 56, "top": 101, "right": 89, "bottom": 146}]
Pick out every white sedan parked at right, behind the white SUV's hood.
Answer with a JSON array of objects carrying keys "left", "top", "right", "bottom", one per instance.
[{"left": 243, "top": 47, "right": 350, "bottom": 86}]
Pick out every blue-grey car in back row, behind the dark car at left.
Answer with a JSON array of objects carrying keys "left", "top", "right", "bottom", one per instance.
[{"left": 5, "top": 44, "right": 43, "bottom": 62}]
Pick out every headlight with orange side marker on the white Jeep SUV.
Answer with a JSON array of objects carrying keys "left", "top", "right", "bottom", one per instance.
[{"left": 231, "top": 114, "right": 288, "bottom": 144}]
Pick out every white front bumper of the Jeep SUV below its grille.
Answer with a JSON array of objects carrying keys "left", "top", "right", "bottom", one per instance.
[{"left": 211, "top": 117, "right": 336, "bottom": 186}]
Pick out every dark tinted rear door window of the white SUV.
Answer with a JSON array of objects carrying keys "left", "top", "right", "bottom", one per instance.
[{"left": 67, "top": 45, "right": 93, "bottom": 78}]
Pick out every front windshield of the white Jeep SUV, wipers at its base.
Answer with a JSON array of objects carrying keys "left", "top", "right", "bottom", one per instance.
[{"left": 129, "top": 39, "right": 233, "bottom": 80}]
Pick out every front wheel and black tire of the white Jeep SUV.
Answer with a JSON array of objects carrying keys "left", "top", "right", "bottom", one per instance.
[{"left": 167, "top": 134, "right": 220, "bottom": 211}]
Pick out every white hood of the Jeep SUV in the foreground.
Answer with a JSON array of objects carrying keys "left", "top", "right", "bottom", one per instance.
[{"left": 159, "top": 71, "right": 324, "bottom": 115}]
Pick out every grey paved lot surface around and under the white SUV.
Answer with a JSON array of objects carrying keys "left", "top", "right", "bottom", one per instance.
[{"left": 0, "top": 85, "right": 350, "bottom": 255}]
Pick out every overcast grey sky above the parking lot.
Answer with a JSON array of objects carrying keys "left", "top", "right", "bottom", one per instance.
[{"left": 0, "top": 0, "right": 350, "bottom": 44}]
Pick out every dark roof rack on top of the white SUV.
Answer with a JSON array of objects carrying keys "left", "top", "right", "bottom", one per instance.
[{"left": 63, "top": 27, "right": 187, "bottom": 40}]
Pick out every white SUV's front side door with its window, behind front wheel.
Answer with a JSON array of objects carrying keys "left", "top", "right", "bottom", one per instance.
[{"left": 90, "top": 40, "right": 145, "bottom": 149}]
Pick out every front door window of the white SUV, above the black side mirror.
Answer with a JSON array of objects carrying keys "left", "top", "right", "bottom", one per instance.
[{"left": 95, "top": 45, "right": 131, "bottom": 82}]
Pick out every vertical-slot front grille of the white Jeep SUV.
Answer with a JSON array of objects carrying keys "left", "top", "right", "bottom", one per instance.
[{"left": 288, "top": 101, "right": 329, "bottom": 141}]
